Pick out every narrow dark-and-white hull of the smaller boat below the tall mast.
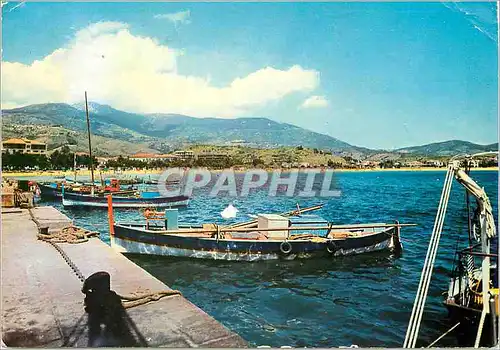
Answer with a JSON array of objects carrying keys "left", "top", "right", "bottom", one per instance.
[{"left": 62, "top": 193, "right": 189, "bottom": 208}]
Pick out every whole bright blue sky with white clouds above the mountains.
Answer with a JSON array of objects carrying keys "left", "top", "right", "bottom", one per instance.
[{"left": 1, "top": 2, "right": 498, "bottom": 149}]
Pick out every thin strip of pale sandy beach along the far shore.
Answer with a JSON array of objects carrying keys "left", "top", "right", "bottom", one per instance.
[{"left": 2, "top": 167, "right": 499, "bottom": 180}]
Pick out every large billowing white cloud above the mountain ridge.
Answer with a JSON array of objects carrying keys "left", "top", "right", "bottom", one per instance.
[{"left": 2, "top": 22, "right": 319, "bottom": 118}]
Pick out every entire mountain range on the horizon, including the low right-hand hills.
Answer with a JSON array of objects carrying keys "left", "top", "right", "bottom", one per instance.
[{"left": 2, "top": 102, "right": 498, "bottom": 158}]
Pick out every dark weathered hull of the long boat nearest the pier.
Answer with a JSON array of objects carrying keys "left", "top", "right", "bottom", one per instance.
[{"left": 111, "top": 224, "right": 395, "bottom": 261}]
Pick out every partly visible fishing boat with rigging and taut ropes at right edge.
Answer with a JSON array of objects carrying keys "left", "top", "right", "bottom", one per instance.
[{"left": 403, "top": 152, "right": 499, "bottom": 348}]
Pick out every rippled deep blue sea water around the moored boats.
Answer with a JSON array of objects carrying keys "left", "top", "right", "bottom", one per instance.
[{"left": 32, "top": 171, "right": 498, "bottom": 347}]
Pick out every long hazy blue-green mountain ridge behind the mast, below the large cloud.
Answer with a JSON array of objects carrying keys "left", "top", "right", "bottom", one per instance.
[{"left": 2, "top": 103, "right": 363, "bottom": 150}]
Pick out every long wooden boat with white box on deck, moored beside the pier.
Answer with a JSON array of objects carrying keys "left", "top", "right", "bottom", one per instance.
[{"left": 109, "top": 201, "right": 406, "bottom": 261}]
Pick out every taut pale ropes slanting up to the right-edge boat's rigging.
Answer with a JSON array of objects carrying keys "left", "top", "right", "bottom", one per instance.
[{"left": 403, "top": 164, "right": 454, "bottom": 348}]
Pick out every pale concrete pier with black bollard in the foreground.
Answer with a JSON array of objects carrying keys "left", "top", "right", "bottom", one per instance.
[{"left": 1, "top": 207, "right": 247, "bottom": 348}]
